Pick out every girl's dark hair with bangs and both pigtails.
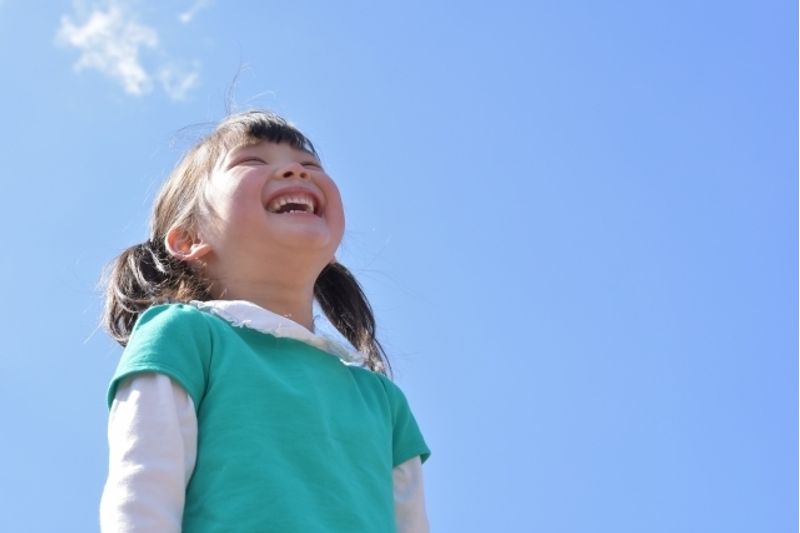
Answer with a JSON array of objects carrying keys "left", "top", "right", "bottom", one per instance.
[{"left": 103, "top": 111, "right": 390, "bottom": 374}]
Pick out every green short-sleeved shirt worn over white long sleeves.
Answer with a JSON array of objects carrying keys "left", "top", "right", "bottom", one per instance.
[{"left": 108, "top": 304, "right": 430, "bottom": 533}]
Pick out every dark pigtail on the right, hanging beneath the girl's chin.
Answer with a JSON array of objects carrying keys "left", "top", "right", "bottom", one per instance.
[{"left": 314, "top": 263, "right": 391, "bottom": 374}]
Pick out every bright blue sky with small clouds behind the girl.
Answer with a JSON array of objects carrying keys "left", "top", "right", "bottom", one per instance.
[{"left": 0, "top": 0, "right": 798, "bottom": 533}]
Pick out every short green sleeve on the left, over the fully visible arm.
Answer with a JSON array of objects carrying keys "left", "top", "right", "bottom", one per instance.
[{"left": 107, "top": 304, "right": 212, "bottom": 408}]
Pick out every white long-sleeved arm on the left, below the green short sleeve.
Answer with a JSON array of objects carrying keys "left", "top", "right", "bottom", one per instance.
[{"left": 100, "top": 373, "right": 197, "bottom": 533}]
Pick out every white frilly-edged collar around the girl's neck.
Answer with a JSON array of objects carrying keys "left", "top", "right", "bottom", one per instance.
[{"left": 189, "top": 300, "right": 364, "bottom": 364}]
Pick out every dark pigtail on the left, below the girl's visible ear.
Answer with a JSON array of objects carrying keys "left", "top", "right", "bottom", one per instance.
[{"left": 103, "top": 239, "right": 210, "bottom": 346}]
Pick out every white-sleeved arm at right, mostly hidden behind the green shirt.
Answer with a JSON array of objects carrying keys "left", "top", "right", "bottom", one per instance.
[{"left": 392, "top": 456, "right": 428, "bottom": 533}]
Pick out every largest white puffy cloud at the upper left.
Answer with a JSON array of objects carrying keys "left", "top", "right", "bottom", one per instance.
[{"left": 56, "top": 2, "right": 158, "bottom": 95}]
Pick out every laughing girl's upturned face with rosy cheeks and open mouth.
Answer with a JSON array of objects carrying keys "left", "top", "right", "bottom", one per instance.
[{"left": 196, "top": 141, "right": 344, "bottom": 277}]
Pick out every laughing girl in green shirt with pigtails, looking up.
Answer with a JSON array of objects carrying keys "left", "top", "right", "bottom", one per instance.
[{"left": 100, "top": 111, "right": 430, "bottom": 533}]
